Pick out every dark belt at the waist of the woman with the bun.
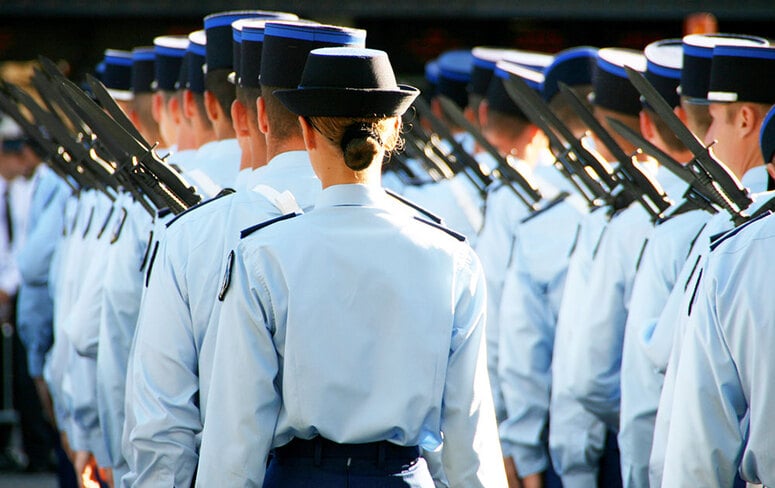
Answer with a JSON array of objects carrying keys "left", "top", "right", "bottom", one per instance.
[{"left": 274, "top": 436, "right": 420, "bottom": 465}]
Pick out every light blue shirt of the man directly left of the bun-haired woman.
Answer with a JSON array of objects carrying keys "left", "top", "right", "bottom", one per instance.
[{"left": 122, "top": 151, "right": 320, "bottom": 487}]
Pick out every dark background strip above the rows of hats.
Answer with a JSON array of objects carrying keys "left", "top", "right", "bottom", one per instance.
[{"left": 0, "top": 0, "right": 775, "bottom": 84}]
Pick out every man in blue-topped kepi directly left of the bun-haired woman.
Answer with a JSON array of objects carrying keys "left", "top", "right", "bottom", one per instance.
[{"left": 124, "top": 22, "right": 366, "bottom": 486}]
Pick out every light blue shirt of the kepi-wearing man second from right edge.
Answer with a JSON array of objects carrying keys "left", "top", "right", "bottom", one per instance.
[{"left": 643, "top": 166, "right": 772, "bottom": 486}]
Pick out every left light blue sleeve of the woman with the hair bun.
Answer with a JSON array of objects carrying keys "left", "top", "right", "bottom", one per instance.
[{"left": 196, "top": 248, "right": 281, "bottom": 486}]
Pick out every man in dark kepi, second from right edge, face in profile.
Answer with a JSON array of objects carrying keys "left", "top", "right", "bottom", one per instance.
[{"left": 649, "top": 45, "right": 775, "bottom": 485}]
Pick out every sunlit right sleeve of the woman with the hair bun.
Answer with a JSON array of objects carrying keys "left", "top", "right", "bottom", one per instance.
[{"left": 441, "top": 250, "right": 506, "bottom": 488}]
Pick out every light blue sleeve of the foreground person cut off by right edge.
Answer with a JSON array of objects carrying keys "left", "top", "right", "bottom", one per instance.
[{"left": 662, "top": 270, "right": 747, "bottom": 488}]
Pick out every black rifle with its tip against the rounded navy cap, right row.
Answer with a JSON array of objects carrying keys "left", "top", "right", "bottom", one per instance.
[{"left": 559, "top": 83, "right": 673, "bottom": 220}]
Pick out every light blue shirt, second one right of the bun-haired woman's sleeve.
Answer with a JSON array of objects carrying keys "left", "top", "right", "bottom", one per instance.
[{"left": 498, "top": 193, "right": 586, "bottom": 477}]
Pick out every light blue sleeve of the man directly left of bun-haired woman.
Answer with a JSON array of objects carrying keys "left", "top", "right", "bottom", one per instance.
[{"left": 124, "top": 233, "right": 202, "bottom": 486}]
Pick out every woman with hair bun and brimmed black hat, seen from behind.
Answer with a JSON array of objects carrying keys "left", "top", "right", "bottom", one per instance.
[{"left": 197, "top": 48, "right": 506, "bottom": 488}]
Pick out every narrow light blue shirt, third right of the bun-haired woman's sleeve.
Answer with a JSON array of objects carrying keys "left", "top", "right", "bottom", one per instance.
[{"left": 549, "top": 208, "right": 608, "bottom": 488}]
